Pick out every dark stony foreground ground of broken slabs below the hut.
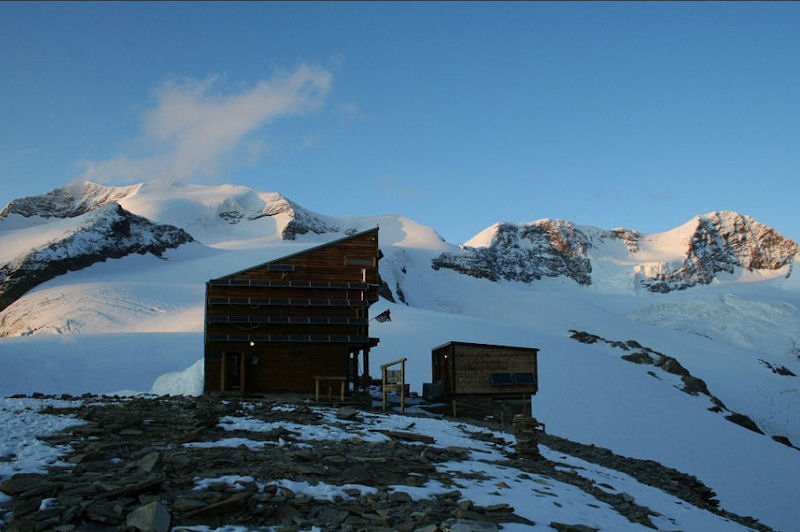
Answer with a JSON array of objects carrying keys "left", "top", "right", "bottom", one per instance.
[{"left": 0, "top": 396, "right": 770, "bottom": 532}]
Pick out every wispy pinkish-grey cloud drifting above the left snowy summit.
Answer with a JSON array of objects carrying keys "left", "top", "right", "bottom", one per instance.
[{"left": 82, "top": 65, "right": 332, "bottom": 183}]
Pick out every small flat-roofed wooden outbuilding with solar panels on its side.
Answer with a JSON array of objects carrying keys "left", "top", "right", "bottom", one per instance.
[{"left": 431, "top": 342, "right": 539, "bottom": 419}]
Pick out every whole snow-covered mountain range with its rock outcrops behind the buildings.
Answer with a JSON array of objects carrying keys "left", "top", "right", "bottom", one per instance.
[{"left": 0, "top": 183, "right": 800, "bottom": 530}]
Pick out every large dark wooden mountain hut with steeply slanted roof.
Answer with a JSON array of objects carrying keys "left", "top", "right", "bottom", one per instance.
[{"left": 205, "top": 228, "right": 379, "bottom": 394}]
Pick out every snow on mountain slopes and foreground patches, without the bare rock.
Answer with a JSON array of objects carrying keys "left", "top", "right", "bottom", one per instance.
[{"left": 0, "top": 184, "right": 800, "bottom": 531}]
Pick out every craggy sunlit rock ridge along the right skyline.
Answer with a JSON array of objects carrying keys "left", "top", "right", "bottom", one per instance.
[{"left": 431, "top": 211, "right": 798, "bottom": 293}]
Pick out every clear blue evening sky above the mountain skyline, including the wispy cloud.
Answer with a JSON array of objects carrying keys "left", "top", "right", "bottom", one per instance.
[{"left": 0, "top": 2, "right": 800, "bottom": 243}]
